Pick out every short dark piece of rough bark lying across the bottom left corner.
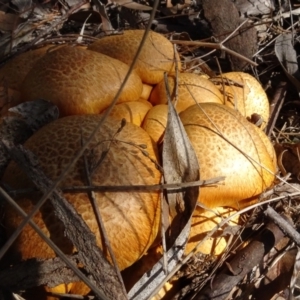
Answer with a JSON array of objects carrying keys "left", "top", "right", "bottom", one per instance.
[{"left": 0, "top": 255, "right": 78, "bottom": 292}]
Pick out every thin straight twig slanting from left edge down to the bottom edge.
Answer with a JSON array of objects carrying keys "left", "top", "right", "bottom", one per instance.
[{"left": 0, "top": 187, "right": 108, "bottom": 300}]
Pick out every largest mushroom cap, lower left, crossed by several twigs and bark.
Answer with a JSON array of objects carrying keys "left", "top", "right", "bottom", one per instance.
[{"left": 3, "top": 115, "right": 161, "bottom": 270}]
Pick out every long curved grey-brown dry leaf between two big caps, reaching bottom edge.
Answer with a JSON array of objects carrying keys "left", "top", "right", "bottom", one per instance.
[{"left": 128, "top": 80, "right": 199, "bottom": 300}]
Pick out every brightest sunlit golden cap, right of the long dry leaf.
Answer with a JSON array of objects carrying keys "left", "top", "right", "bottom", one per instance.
[{"left": 180, "top": 103, "right": 276, "bottom": 209}]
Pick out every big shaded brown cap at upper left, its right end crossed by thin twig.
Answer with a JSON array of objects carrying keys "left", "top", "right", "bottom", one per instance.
[{"left": 21, "top": 46, "right": 142, "bottom": 116}]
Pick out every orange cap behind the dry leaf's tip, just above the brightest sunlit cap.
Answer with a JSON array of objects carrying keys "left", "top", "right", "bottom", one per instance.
[{"left": 149, "top": 73, "right": 224, "bottom": 112}]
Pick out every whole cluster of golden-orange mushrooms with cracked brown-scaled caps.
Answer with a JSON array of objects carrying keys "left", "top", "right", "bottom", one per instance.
[{"left": 0, "top": 30, "right": 276, "bottom": 300}]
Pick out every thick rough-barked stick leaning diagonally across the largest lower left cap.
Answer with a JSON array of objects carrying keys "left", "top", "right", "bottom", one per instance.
[{"left": 3, "top": 141, "right": 127, "bottom": 299}]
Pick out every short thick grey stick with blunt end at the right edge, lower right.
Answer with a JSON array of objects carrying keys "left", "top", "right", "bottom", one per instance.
[{"left": 265, "top": 206, "right": 300, "bottom": 247}]
